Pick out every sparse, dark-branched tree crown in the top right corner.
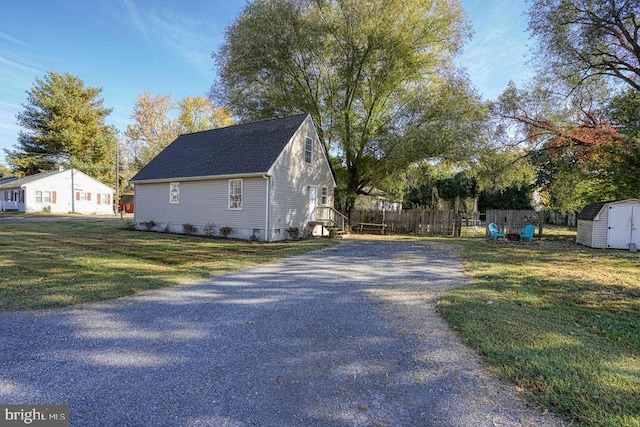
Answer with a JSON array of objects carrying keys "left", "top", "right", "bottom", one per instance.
[{"left": 529, "top": 0, "right": 640, "bottom": 91}]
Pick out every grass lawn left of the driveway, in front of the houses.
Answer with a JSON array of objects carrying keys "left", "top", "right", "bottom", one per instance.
[{"left": 0, "top": 220, "right": 335, "bottom": 309}]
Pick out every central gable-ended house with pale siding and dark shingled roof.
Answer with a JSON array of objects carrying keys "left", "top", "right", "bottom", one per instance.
[{"left": 130, "top": 114, "right": 340, "bottom": 241}]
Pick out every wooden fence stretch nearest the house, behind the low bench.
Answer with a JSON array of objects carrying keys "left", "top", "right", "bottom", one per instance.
[{"left": 350, "top": 209, "right": 462, "bottom": 236}]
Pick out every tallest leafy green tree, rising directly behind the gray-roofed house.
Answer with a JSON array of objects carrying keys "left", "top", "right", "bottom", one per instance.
[{"left": 212, "top": 0, "right": 484, "bottom": 214}]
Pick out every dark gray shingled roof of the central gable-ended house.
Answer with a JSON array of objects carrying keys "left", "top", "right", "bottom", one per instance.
[{"left": 131, "top": 114, "right": 308, "bottom": 182}]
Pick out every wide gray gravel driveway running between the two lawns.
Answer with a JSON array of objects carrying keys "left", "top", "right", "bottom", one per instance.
[{"left": 0, "top": 240, "right": 560, "bottom": 426}]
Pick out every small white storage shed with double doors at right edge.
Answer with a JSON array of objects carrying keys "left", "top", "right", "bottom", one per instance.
[{"left": 576, "top": 199, "right": 640, "bottom": 249}]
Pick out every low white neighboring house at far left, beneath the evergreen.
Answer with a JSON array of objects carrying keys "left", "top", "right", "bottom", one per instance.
[{"left": 0, "top": 169, "right": 113, "bottom": 214}]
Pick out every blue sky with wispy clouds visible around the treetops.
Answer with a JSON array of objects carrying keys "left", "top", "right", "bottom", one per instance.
[{"left": 0, "top": 0, "right": 532, "bottom": 164}]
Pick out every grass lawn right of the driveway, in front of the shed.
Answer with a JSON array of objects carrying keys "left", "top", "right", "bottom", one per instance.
[{"left": 439, "top": 228, "right": 640, "bottom": 426}]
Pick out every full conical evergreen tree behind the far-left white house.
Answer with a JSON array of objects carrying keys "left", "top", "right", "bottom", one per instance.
[{"left": 5, "top": 71, "right": 116, "bottom": 183}]
